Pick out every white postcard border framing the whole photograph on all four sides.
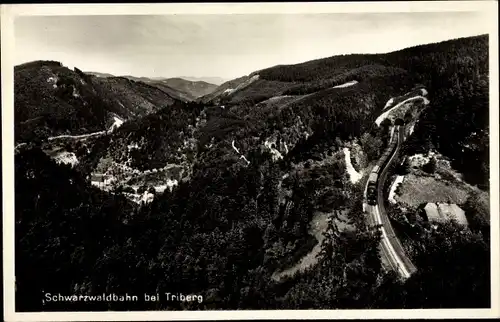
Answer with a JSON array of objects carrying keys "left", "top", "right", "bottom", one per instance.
[{"left": 1, "top": 1, "right": 500, "bottom": 321}]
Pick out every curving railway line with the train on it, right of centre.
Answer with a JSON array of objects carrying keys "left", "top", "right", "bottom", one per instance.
[{"left": 364, "top": 125, "right": 417, "bottom": 279}]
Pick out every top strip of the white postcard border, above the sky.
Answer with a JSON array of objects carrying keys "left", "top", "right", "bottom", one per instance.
[{"left": 2, "top": 1, "right": 495, "bottom": 16}]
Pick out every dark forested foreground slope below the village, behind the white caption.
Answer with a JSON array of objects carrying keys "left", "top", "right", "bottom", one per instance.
[{"left": 15, "top": 142, "right": 489, "bottom": 311}]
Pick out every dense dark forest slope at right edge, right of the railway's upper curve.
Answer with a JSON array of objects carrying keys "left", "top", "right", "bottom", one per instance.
[{"left": 389, "top": 36, "right": 489, "bottom": 189}]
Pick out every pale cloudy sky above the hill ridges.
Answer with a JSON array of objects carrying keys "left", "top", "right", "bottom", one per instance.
[{"left": 14, "top": 12, "right": 488, "bottom": 80}]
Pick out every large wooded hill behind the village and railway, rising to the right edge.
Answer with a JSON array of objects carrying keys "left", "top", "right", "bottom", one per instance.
[{"left": 78, "top": 36, "right": 488, "bottom": 199}]
